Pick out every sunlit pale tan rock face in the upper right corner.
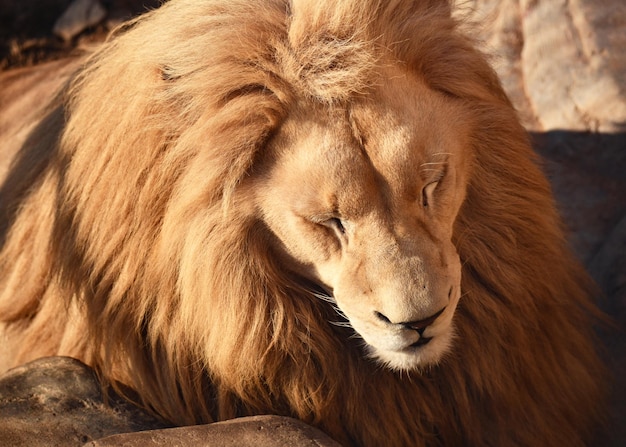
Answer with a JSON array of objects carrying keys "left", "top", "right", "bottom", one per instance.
[{"left": 522, "top": 0, "right": 626, "bottom": 132}]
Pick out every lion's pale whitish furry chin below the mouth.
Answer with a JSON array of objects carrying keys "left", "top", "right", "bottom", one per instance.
[{"left": 367, "top": 331, "right": 453, "bottom": 371}]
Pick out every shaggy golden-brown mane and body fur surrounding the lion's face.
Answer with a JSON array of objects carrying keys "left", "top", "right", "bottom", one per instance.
[{"left": 0, "top": 0, "right": 602, "bottom": 446}]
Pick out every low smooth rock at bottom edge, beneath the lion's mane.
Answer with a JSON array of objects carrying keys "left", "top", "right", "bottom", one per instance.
[{"left": 86, "top": 416, "right": 339, "bottom": 447}]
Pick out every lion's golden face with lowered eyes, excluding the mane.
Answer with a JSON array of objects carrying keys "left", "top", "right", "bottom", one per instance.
[{"left": 255, "top": 72, "right": 469, "bottom": 370}]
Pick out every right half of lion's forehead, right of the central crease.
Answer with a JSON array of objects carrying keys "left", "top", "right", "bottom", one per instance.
[{"left": 351, "top": 73, "right": 470, "bottom": 179}]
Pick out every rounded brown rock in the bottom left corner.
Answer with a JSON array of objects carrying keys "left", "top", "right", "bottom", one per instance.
[{"left": 0, "top": 357, "right": 167, "bottom": 447}]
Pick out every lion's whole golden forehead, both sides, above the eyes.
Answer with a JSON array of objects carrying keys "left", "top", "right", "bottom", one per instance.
[{"left": 272, "top": 67, "right": 469, "bottom": 223}]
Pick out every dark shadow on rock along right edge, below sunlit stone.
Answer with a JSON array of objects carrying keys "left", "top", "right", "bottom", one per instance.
[{"left": 532, "top": 130, "right": 626, "bottom": 446}]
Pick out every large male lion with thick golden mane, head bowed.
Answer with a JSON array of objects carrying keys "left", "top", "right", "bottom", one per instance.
[{"left": 0, "top": 0, "right": 604, "bottom": 446}]
